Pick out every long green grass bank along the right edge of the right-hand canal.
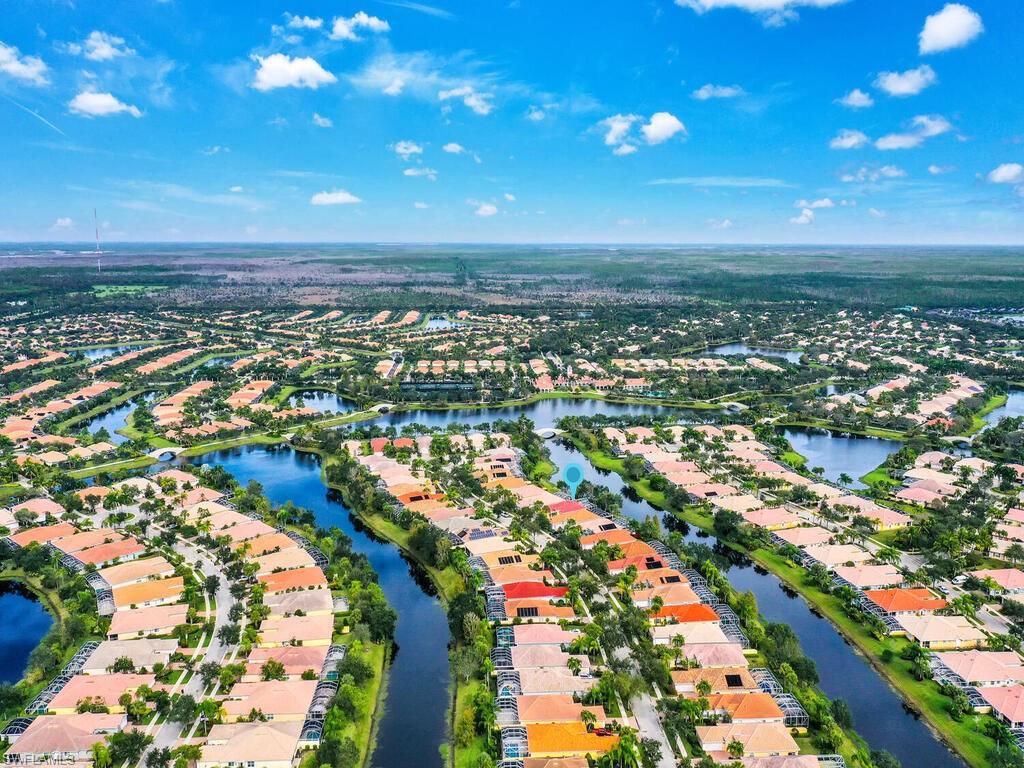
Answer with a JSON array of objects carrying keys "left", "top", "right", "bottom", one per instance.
[{"left": 572, "top": 439, "right": 994, "bottom": 768}]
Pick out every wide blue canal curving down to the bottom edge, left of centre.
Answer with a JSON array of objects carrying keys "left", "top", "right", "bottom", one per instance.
[{"left": 185, "top": 445, "right": 449, "bottom": 768}]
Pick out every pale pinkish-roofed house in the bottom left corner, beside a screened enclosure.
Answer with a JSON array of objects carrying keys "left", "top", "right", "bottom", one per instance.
[{"left": 4, "top": 713, "right": 127, "bottom": 765}]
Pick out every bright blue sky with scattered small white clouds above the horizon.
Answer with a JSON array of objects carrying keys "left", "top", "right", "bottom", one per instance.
[{"left": 0, "top": 0, "right": 1024, "bottom": 244}]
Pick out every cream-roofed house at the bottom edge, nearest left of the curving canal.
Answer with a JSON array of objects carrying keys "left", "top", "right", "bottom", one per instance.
[{"left": 196, "top": 720, "right": 302, "bottom": 768}]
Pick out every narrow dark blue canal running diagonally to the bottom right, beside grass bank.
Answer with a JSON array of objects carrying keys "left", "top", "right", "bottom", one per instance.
[{"left": 548, "top": 442, "right": 965, "bottom": 768}]
